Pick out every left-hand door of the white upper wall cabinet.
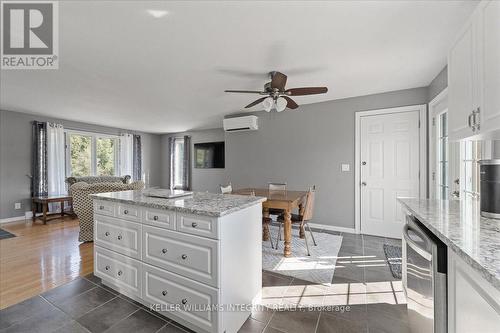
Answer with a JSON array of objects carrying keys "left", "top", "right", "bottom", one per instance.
[{"left": 448, "top": 20, "right": 476, "bottom": 140}]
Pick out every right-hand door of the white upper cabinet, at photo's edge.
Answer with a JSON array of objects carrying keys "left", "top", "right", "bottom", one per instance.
[{"left": 477, "top": 1, "right": 500, "bottom": 132}]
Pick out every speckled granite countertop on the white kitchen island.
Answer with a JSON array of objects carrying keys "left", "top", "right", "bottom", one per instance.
[{"left": 91, "top": 191, "right": 266, "bottom": 217}]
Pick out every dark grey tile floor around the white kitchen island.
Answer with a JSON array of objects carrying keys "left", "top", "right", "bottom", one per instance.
[{"left": 0, "top": 234, "right": 408, "bottom": 333}]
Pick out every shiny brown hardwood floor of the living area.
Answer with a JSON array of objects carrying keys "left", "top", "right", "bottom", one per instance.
[{"left": 0, "top": 219, "right": 94, "bottom": 309}]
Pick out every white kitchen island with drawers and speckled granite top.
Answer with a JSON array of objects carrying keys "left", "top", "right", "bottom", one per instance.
[{"left": 93, "top": 191, "right": 265, "bottom": 333}]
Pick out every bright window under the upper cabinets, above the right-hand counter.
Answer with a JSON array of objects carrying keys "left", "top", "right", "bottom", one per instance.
[{"left": 460, "top": 141, "right": 481, "bottom": 197}]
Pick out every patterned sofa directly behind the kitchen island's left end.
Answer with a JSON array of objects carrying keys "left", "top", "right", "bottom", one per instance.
[{"left": 70, "top": 181, "right": 144, "bottom": 242}]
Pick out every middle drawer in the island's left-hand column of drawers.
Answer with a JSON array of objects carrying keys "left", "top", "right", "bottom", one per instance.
[{"left": 94, "top": 215, "right": 142, "bottom": 259}]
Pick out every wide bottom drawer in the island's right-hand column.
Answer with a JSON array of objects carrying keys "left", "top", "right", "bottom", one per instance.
[{"left": 142, "top": 264, "right": 218, "bottom": 333}]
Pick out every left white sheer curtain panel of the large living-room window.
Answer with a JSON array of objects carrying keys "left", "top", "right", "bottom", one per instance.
[{"left": 47, "top": 123, "right": 67, "bottom": 211}]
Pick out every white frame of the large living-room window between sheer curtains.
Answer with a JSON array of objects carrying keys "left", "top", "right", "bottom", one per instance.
[{"left": 64, "top": 129, "right": 120, "bottom": 177}]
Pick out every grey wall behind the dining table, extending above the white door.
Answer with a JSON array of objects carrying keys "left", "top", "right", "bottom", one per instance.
[{"left": 226, "top": 88, "right": 428, "bottom": 228}]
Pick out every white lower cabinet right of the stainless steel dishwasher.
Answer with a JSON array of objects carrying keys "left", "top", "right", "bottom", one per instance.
[{"left": 448, "top": 250, "right": 500, "bottom": 333}]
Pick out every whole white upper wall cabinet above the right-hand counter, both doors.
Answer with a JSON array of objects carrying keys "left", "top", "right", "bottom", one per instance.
[{"left": 448, "top": 0, "right": 500, "bottom": 140}]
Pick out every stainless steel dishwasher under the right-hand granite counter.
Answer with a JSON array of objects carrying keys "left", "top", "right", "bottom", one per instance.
[{"left": 403, "top": 215, "right": 447, "bottom": 333}]
